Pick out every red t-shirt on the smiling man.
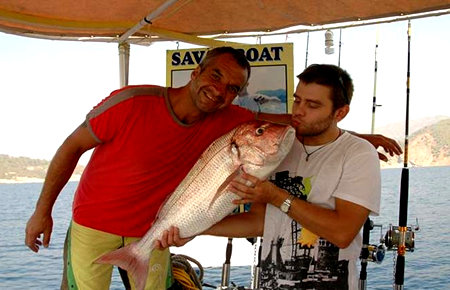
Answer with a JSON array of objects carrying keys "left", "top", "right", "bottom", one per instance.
[{"left": 73, "top": 86, "right": 253, "bottom": 237}]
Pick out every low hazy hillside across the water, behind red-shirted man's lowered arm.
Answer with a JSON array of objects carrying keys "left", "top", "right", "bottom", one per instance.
[{"left": 0, "top": 154, "right": 84, "bottom": 183}]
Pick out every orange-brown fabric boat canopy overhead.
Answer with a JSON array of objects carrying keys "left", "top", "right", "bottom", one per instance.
[{"left": 0, "top": 0, "right": 450, "bottom": 44}]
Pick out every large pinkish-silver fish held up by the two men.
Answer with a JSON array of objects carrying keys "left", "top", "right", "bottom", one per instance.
[{"left": 96, "top": 121, "right": 295, "bottom": 289}]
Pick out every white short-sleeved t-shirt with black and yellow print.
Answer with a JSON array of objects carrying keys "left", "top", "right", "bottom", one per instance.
[{"left": 261, "top": 132, "right": 381, "bottom": 289}]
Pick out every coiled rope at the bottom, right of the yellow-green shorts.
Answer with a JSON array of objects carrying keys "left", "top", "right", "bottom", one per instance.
[{"left": 172, "top": 255, "right": 203, "bottom": 290}]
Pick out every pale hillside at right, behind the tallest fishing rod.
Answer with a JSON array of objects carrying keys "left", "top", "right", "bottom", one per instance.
[{"left": 380, "top": 118, "right": 450, "bottom": 167}]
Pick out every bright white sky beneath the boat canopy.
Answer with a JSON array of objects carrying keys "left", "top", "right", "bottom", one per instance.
[{"left": 0, "top": 15, "right": 450, "bottom": 164}]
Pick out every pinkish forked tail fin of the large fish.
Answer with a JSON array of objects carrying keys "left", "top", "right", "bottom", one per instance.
[{"left": 95, "top": 242, "right": 149, "bottom": 290}]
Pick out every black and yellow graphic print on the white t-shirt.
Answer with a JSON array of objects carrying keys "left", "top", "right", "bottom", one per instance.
[{"left": 260, "top": 171, "right": 348, "bottom": 289}]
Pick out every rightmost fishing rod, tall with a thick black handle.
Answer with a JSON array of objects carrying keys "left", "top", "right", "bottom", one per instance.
[{"left": 394, "top": 20, "right": 411, "bottom": 290}]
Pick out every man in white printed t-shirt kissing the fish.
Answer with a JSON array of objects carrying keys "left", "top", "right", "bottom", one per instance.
[{"left": 158, "top": 65, "right": 381, "bottom": 289}]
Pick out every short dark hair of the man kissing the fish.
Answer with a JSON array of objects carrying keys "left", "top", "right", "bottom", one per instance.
[{"left": 297, "top": 64, "right": 353, "bottom": 110}]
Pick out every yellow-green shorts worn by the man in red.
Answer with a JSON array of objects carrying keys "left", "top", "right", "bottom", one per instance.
[{"left": 61, "top": 221, "right": 173, "bottom": 290}]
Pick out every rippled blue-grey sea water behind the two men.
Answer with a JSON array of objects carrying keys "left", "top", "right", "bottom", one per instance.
[{"left": 0, "top": 167, "right": 450, "bottom": 289}]
